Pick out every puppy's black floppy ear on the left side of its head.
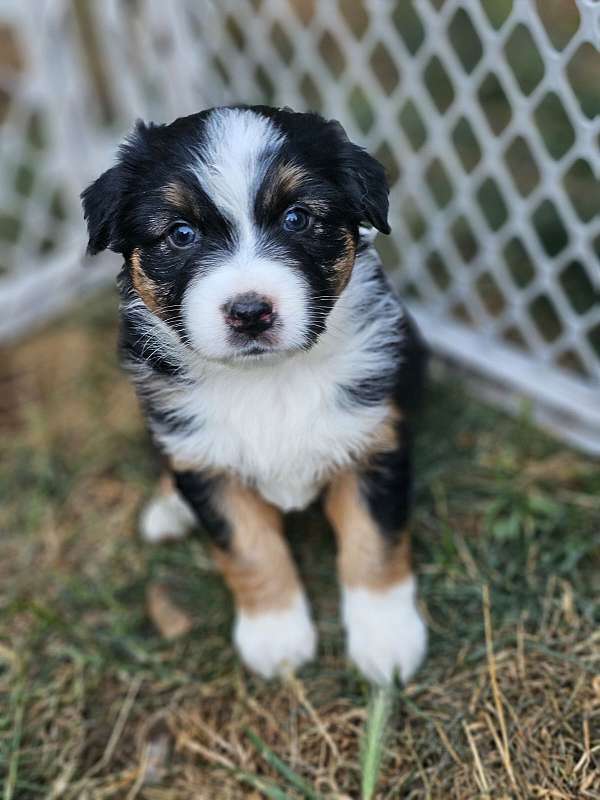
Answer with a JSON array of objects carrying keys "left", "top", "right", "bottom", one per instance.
[{"left": 81, "top": 166, "right": 122, "bottom": 255}]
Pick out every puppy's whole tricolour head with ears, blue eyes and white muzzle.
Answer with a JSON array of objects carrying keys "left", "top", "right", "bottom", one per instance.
[{"left": 82, "top": 106, "right": 389, "bottom": 361}]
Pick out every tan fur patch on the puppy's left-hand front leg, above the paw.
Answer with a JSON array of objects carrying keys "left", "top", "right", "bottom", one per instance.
[{"left": 214, "top": 480, "right": 301, "bottom": 614}]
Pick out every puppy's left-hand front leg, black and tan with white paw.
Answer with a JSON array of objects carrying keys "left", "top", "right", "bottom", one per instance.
[{"left": 175, "top": 471, "right": 317, "bottom": 678}]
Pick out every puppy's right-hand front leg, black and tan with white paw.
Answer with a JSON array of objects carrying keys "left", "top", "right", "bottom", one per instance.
[{"left": 326, "top": 428, "right": 427, "bottom": 684}]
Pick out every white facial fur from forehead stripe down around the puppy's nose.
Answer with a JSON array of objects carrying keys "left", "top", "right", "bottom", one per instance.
[{"left": 182, "top": 108, "right": 308, "bottom": 359}]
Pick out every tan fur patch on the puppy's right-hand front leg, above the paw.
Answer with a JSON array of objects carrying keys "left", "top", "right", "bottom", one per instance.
[{"left": 325, "top": 472, "right": 411, "bottom": 591}]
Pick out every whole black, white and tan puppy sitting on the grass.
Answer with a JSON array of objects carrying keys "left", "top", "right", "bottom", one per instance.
[{"left": 82, "top": 106, "right": 426, "bottom": 683}]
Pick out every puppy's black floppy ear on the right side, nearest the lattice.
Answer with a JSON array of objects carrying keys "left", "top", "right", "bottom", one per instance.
[{"left": 329, "top": 120, "right": 391, "bottom": 233}]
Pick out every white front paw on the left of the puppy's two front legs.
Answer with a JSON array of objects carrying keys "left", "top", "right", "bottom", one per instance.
[{"left": 233, "top": 594, "right": 317, "bottom": 678}]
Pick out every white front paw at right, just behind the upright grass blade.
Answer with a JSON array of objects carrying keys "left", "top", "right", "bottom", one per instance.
[{"left": 342, "top": 577, "right": 427, "bottom": 684}]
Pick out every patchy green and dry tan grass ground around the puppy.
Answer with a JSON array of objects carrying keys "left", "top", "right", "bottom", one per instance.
[{"left": 0, "top": 290, "right": 600, "bottom": 800}]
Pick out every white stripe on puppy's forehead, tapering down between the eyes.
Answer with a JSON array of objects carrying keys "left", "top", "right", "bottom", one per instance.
[{"left": 193, "top": 108, "right": 284, "bottom": 234}]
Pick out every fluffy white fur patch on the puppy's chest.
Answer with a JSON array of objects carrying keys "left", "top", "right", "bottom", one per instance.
[{"left": 152, "top": 332, "right": 386, "bottom": 510}]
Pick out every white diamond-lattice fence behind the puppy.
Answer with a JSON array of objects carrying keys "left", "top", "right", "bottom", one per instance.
[{"left": 0, "top": 0, "right": 600, "bottom": 453}]
